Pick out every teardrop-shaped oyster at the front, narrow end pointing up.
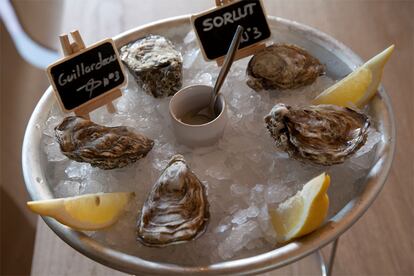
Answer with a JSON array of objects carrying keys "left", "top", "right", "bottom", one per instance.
[{"left": 137, "top": 155, "right": 210, "bottom": 247}]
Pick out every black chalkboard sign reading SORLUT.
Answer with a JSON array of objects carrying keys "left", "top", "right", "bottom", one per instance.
[{"left": 192, "top": 0, "right": 270, "bottom": 60}]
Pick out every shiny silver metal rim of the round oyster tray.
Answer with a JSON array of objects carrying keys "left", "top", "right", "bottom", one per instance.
[{"left": 22, "top": 16, "right": 395, "bottom": 275}]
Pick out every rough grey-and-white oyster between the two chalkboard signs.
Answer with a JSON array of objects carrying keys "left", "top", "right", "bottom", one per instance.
[{"left": 120, "top": 35, "right": 183, "bottom": 98}]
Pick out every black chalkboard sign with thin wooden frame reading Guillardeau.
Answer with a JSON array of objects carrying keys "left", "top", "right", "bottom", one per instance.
[{"left": 47, "top": 39, "right": 126, "bottom": 111}]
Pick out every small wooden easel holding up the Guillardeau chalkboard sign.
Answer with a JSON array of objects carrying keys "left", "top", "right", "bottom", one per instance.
[{"left": 59, "top": 30, "right": 122, "bottom": 119}]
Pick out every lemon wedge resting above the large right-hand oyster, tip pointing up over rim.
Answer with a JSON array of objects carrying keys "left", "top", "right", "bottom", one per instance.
[{"left": 313, "top": 45, "right": 394, "bottom": 107}]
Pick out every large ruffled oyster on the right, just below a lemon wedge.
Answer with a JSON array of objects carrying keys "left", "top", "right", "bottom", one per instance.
[{"left": 265, "top": 104, "right": 370, "bottom": 165}]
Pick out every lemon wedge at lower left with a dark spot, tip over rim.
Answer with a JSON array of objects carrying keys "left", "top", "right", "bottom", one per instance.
[{"left": 27, "top": 193, "right": 134, "bottom": 230}]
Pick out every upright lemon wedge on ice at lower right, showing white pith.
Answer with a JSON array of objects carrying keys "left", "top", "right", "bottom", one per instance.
[{"left": 269, "top": 173, "right": 330, "bottom": 243}]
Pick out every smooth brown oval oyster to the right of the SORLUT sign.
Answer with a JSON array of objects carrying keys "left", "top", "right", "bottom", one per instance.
[{"left": 247, "top": 44, "right": 324, "bottom": 91}]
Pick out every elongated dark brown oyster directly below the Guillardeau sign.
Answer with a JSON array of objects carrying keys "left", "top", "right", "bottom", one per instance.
[{"left": 55, "top": 116, "right": 154, "bottom": 170}]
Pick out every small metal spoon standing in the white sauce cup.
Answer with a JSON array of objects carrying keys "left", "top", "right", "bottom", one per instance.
[{"left": 193, "top": 25, "right": 244, "bottom": 121}]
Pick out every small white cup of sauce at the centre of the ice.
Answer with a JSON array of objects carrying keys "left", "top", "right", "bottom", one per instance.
[{"left": 169, "top": 85, "right": 227, "bottom": 147}]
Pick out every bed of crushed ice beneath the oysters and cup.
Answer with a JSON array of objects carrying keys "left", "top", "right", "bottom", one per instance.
[{"left": 43, "top": 29, "right": 381, "bottom": 265}]
